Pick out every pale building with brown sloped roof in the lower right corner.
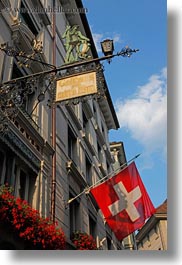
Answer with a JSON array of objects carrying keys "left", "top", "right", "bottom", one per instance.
[{"left": 136, "top": 200, "right": 167, "bottom": 250}]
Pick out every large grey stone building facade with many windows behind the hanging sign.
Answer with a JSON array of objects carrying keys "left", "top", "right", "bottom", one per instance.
[{"left": 0, "top": 0, "right": 123, "bottom": 250}]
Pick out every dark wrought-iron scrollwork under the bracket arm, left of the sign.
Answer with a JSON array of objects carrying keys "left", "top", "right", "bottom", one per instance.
[{"left": 0, "top": 70, "right": 56, "bottom": 132}]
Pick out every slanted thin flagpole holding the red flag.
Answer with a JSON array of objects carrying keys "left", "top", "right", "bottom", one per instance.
[{"left": 66, "top": 154, "right": 141, "bottom": 206}]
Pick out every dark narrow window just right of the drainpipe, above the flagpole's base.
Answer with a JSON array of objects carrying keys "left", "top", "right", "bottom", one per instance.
[{"left": 68, "top": 127, "right": 77, "bottom": 163}]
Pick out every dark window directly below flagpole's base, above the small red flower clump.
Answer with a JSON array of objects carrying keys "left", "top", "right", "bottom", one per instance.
[{"left": 69, "top": 193, "right": 80, "bottom": 237}]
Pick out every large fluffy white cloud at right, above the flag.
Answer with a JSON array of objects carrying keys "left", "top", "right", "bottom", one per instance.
[{"left": 116, "top": 68, "right": 167, "bottom": 160}]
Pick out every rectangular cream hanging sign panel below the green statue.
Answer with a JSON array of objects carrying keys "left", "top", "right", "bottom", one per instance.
[{"left": 56, "top": 71, "right": 97, "bottom": 102}]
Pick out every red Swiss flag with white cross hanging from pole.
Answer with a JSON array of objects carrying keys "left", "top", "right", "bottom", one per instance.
[{"left": 90, "top": 162, "right": 155, "bottom": 240}]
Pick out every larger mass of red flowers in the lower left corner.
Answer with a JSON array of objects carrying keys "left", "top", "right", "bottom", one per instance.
[{"left": 0, "top": 185, "right": 65, "bottom": 249}]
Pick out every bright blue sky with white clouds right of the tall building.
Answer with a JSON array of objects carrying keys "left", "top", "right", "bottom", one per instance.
[{"left": 83, "top": 0, "right": 167, "bottom": 207}]
